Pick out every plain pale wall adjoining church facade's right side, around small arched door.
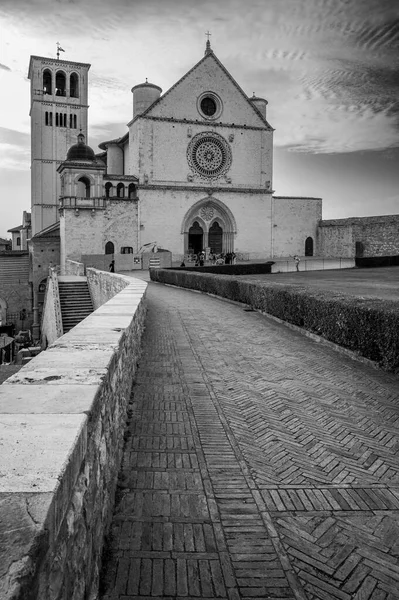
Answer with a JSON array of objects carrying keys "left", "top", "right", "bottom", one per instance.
[{"left": 272, "top": 196, "right": 322, "bottom": 257}]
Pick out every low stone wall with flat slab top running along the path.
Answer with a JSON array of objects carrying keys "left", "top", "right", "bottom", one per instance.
[{"left": 0, "top": 273, "right": 147, "bottom": 600}]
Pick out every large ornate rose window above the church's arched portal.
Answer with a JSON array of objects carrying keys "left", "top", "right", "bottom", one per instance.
[{"left": 187, "top": 131, "right": 232, "bottom": 179}]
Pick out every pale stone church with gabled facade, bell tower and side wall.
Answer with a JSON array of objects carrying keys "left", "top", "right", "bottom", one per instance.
[{"left": 30, "top": 42, "right": 321, "bottom": 272}]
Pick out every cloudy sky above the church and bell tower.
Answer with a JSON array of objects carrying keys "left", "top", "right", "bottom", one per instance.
[{"left": 0, "top": 0, "right": 399, "bottom": 238}]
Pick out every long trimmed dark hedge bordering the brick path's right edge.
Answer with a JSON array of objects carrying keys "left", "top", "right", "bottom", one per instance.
[{"left": 150, "top": 269, "right": 399, "bottom": 372}]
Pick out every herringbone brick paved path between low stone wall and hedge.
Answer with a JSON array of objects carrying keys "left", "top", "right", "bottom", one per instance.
[{"left": 102, "top": 284, "right": 399, "bottom": 600}]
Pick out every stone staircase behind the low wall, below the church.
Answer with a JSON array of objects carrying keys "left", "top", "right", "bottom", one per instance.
[{"left": 58, "top": 276, "right": 93, "bottom": 333}]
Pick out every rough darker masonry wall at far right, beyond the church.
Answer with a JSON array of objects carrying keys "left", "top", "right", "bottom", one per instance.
[{"left": 319, "top": 215, "right": 399, "bottom": 257}]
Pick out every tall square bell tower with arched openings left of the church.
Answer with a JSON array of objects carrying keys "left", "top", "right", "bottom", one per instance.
[{"left": 28, "top": 56, "right": 90, "bottom": 235}]
